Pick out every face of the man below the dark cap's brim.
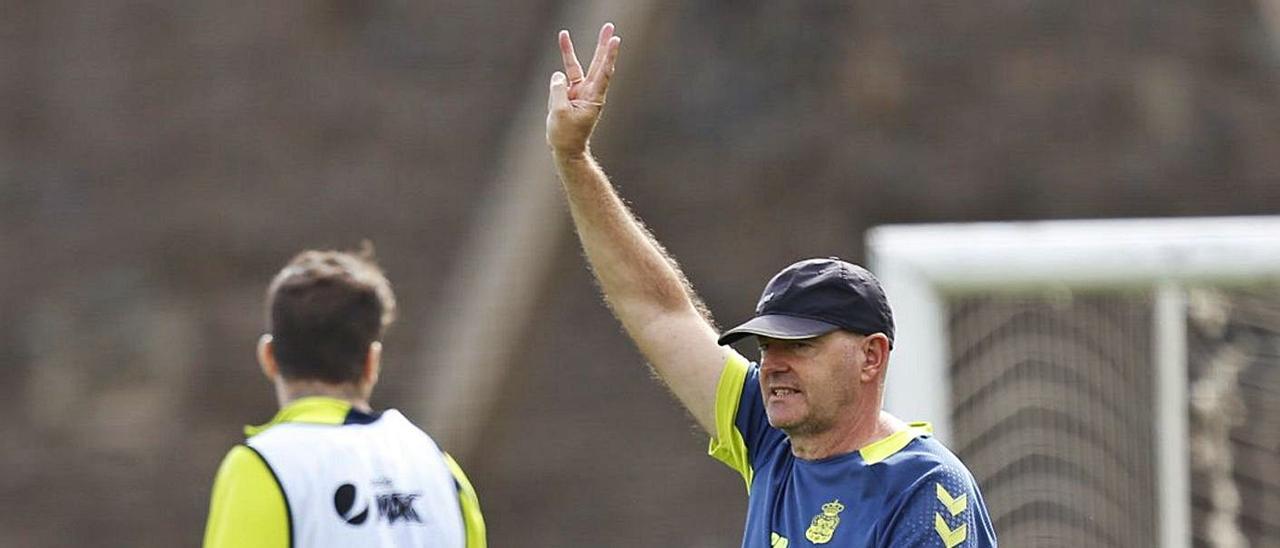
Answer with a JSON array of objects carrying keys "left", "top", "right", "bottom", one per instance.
[{"left": 758, "top": 332, "right": 865, "bottom": 435}]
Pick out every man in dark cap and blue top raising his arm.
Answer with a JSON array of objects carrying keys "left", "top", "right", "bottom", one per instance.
[{"left": 547, "top": 24, "right": 996, "bottom": 548}]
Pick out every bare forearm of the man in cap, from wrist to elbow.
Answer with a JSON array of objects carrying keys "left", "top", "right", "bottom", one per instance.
[{"left": 554, "top": 152, "right": 705, "bottom": 325}]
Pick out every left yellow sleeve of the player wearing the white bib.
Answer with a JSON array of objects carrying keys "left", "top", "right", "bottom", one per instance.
[{"left": 205, "top": 446, "right": 291, "bottom": 548}]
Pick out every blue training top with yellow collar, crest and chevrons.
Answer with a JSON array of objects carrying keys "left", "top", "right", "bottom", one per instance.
[{"left": 709, "top": 352, "right": 996, "bottom": 548}]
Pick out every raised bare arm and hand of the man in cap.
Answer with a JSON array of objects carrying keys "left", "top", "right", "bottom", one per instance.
[{"left": 547, "top": 23, "right": 727, "bottom": 435}]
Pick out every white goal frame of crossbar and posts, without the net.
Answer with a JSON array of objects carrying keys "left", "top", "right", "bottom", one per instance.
[{"left": 867, "top": 216, "right": 1280, "bottom": 547}]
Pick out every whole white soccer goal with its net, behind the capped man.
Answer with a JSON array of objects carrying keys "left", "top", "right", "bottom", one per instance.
[{"left": 867, "top": 216, "right": 1280, "bottom": 548}]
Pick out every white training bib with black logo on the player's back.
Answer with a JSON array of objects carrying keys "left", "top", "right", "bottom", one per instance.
[{"left": 246, "top": 399, "right": 466, "bottom": 548}]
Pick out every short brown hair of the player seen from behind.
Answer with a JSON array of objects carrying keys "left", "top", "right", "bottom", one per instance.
[{"left": 266, "top": 243, "right": 396, "bottom": 384}]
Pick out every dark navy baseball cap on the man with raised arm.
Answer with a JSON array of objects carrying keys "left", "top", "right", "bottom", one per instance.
[{"left": 719, "top": 257, "right": 893, "bottom": 347}]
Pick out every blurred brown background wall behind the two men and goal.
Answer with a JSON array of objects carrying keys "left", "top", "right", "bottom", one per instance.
[{"left": 0, "top": 0, "right": 1280, "bottom": 547}]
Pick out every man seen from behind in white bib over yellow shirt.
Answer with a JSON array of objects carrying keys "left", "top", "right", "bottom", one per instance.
[{"left": 205, "top": 251, "right": 485, "bottom": 548}]
